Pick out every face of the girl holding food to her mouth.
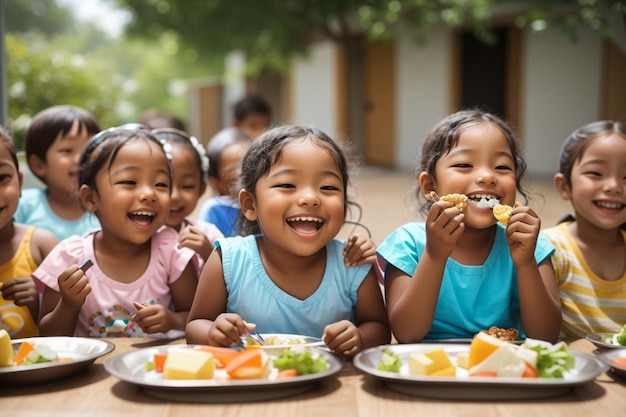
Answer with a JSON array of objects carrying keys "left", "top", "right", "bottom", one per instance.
[{"left": 420, "top": 123, "right": 517, "bottom": 229}]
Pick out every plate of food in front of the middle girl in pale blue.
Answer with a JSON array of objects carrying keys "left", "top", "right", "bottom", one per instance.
[{"left": 104, "top": 345, "right": 344, "bottom": 403}]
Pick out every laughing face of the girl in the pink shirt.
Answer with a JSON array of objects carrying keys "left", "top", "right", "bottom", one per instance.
[{"left": 80, "top": 138, "right": 170, "bottom": 244}]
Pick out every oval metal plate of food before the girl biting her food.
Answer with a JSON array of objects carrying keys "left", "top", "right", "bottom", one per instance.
[{"left": 354, "top": 333, "right": 608, "bottom": 400}]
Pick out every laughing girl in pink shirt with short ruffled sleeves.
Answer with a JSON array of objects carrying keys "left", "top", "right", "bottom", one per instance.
[{"left": 33, "top": 128, "right": 197, "bottom": 337}]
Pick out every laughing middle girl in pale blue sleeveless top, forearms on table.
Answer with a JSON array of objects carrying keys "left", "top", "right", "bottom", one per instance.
[{"left": 186, "top": 126, "right": 391, "bottom": 357}]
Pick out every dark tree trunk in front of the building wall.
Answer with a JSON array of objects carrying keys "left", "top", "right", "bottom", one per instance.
[{"left": 342, "top": 35, "right": 367, "bottom": 157}]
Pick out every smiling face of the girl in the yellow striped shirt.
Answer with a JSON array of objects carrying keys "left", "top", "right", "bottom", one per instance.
[{"left": 557, "top": 134, "right": 626, "bottom": 230}]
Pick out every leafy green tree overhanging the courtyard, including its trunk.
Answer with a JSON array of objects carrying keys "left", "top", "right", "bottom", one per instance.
[{"left": 117, "top": 0, "right": 626, "bottom": 147}]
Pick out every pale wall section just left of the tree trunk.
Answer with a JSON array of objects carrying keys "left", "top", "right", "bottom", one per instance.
[{"left": 291, "top": 42, "right": 338, "bottom": 137}]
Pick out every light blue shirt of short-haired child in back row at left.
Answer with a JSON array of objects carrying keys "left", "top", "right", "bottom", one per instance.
[{"left": 13, "top": 188, "right": 100, "bottom": 240}]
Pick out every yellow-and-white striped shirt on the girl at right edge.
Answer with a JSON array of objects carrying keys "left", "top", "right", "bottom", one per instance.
[{"left": 542, "top": 222, "right": 626, "bottom": 338}]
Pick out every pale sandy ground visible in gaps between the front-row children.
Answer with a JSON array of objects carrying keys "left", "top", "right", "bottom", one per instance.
[{"left": 198, "top": 167, "right": 570, "bottom": 243}]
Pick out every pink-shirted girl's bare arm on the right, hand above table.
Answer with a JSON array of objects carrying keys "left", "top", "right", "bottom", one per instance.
[{"left": 133, "top": 262, "right": 197, "bottom": 334}]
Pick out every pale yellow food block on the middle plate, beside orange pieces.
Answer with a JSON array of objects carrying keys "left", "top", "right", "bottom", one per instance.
[{"left": 163, "top": 349, "right": 215, "bottom": 379}]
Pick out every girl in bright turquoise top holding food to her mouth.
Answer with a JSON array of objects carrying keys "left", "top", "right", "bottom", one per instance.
[{"left": 378, "top": 110, "right": 561, "bottom": 343}]
